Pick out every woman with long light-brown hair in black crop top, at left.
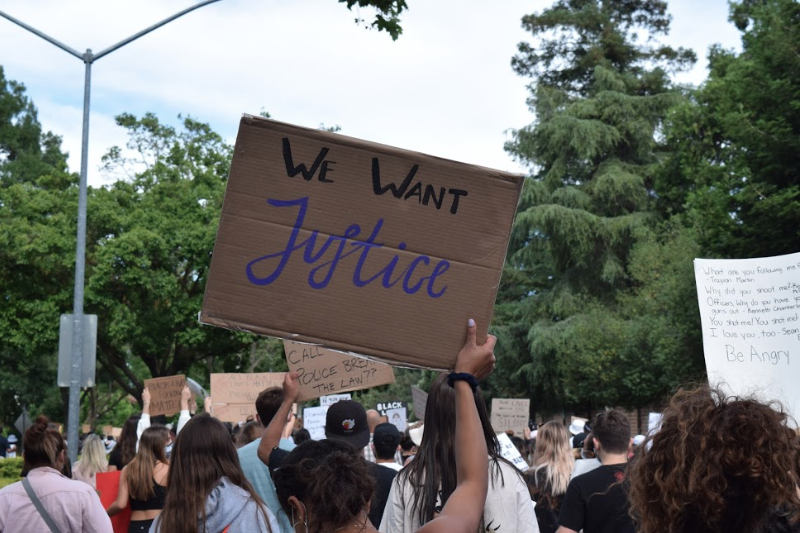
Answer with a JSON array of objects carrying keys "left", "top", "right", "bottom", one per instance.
[{"left": 108, "top": 426, "right": 171, "bottom": 533}]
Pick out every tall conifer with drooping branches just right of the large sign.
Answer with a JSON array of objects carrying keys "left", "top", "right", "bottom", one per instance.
[{"left": 504, "top": 0, "right": 702, "bottom": 409}]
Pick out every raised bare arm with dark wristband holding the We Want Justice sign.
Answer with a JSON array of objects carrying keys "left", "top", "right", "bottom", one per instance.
[{"left": 418, "top": 319, "right": 497, "bottom": 533}]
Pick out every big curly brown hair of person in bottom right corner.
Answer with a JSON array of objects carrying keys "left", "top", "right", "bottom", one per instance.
[{"left": 627, "top": 386, "right": 800, "bottom": 533}]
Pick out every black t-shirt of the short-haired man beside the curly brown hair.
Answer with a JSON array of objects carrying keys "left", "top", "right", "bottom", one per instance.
[{"left": 558, "top": 464, "right": 636, "bottom": 533}]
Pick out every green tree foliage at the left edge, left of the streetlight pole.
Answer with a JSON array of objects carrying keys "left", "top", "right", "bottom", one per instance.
[{"left": 0, "top": 67, "right": 77, "bottom": 423}]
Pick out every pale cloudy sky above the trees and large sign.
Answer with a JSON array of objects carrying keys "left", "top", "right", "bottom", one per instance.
[{"left": 0, "top": 0, "right": 740, "bottom": 186}]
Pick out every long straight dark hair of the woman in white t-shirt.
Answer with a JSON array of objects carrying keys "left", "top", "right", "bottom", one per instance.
[{"left": 397, "top": 374, "right": 521, "bottom": 524}]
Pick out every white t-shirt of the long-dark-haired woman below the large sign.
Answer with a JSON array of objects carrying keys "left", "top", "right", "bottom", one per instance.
[{"left": 379, "top": 459, "right": 539, "bottom": 533}]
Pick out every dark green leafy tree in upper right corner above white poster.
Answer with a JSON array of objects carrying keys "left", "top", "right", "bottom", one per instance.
[{"left": 659, "top": 0, "right": 800, "bottom": 258}]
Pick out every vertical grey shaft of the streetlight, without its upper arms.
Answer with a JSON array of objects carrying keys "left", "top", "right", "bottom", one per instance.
[{"left": 67, "top": 49, "right": 94, "bottom": 463}]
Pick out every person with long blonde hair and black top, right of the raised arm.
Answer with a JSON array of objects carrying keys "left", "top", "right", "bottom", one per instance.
[{"left": 525, "top": 422, "right": 575, "bottom": 533}]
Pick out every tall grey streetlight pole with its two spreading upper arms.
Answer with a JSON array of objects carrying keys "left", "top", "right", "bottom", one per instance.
[{"left": 0, "top": 0, "right": 219, "bottom": 463}]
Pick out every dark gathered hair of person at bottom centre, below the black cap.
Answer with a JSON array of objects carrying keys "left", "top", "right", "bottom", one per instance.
[{"left": 273, "top": 439, "right": 375, "bottom": 531}]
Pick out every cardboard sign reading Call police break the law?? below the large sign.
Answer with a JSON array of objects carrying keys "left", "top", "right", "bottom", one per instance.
[{"left": 283, "top": 341, "right": 394, "bottom": 401}]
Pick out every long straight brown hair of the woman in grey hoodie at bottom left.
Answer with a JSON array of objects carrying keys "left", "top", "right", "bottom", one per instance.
[{"left": 153, "top": 413, "right": 272, "bottom": 533}]
